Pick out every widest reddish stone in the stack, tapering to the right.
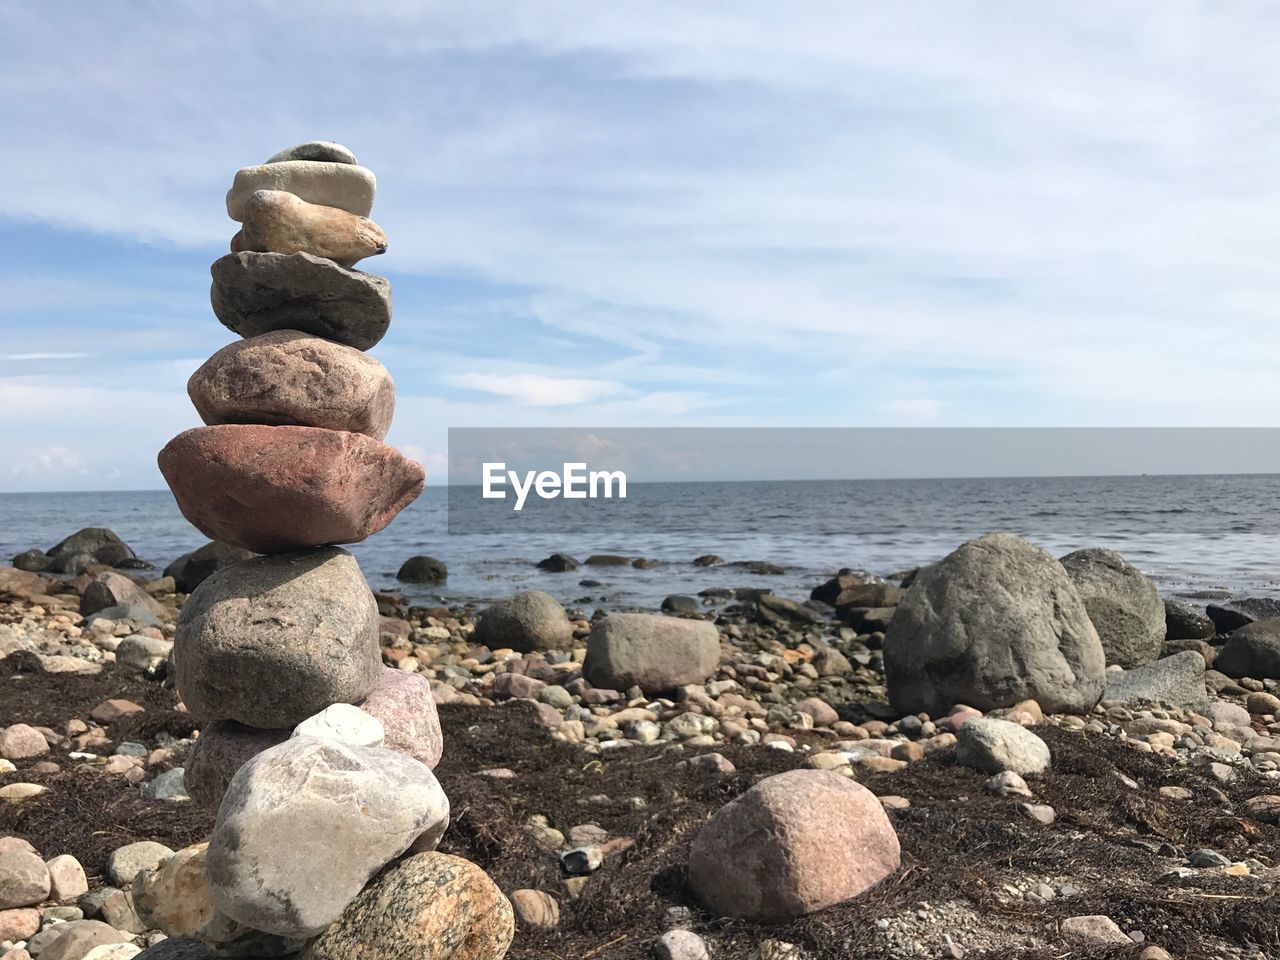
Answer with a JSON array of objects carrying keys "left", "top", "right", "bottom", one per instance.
[{"left": 159, "top": 424, "right": 424, "bottom": 553}]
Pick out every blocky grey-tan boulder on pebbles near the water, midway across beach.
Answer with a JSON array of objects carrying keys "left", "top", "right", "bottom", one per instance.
[{"left": 582, "top": 613, "right": 719, "bottom": 694}]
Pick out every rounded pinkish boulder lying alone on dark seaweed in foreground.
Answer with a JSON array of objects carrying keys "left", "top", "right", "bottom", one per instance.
[{"left": 689, "top": 769, "right": 900, "bottom": 922}]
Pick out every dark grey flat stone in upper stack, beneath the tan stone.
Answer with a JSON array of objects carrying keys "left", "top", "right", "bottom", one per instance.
[{"left": 210, "top": 252, "right": 392, "bottom": 349}]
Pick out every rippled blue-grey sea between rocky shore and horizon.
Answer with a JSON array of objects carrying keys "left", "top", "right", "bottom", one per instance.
[{"left": 0, "top": 474, "right": 1280, "bottom": 609}]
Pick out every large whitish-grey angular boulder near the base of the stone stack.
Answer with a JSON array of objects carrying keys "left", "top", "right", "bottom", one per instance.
[{"left": 207, "top": 737, "right": 449, "bottom": 938}]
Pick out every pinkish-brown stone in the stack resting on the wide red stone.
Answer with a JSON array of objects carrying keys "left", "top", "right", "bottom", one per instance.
[{"left": 187, "top": 330, "right": 396, "bottom": 440}]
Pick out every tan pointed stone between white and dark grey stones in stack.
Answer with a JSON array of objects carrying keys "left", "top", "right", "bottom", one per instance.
[{"left": 232, "top": 189, "right": 387, "bottom": 268}]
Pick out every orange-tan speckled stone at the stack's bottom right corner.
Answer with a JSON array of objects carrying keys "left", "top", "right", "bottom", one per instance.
[{"left": 300, "top": 854, "right": 516, "bottom": 960}]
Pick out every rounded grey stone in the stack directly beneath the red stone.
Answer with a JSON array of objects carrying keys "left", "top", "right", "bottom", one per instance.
[{"left": 174, "top": 547, "right": 381, "bottom": 728}]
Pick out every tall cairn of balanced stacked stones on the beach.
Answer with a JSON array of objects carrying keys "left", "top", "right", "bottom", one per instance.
[{"left": 147, "top": 141, "right": 513, "bottom": 960}]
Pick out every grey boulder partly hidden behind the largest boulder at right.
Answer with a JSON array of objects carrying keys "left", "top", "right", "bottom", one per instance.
[{"left": 1061, "top": 547, "right": 1166, "bottom": 669}]
